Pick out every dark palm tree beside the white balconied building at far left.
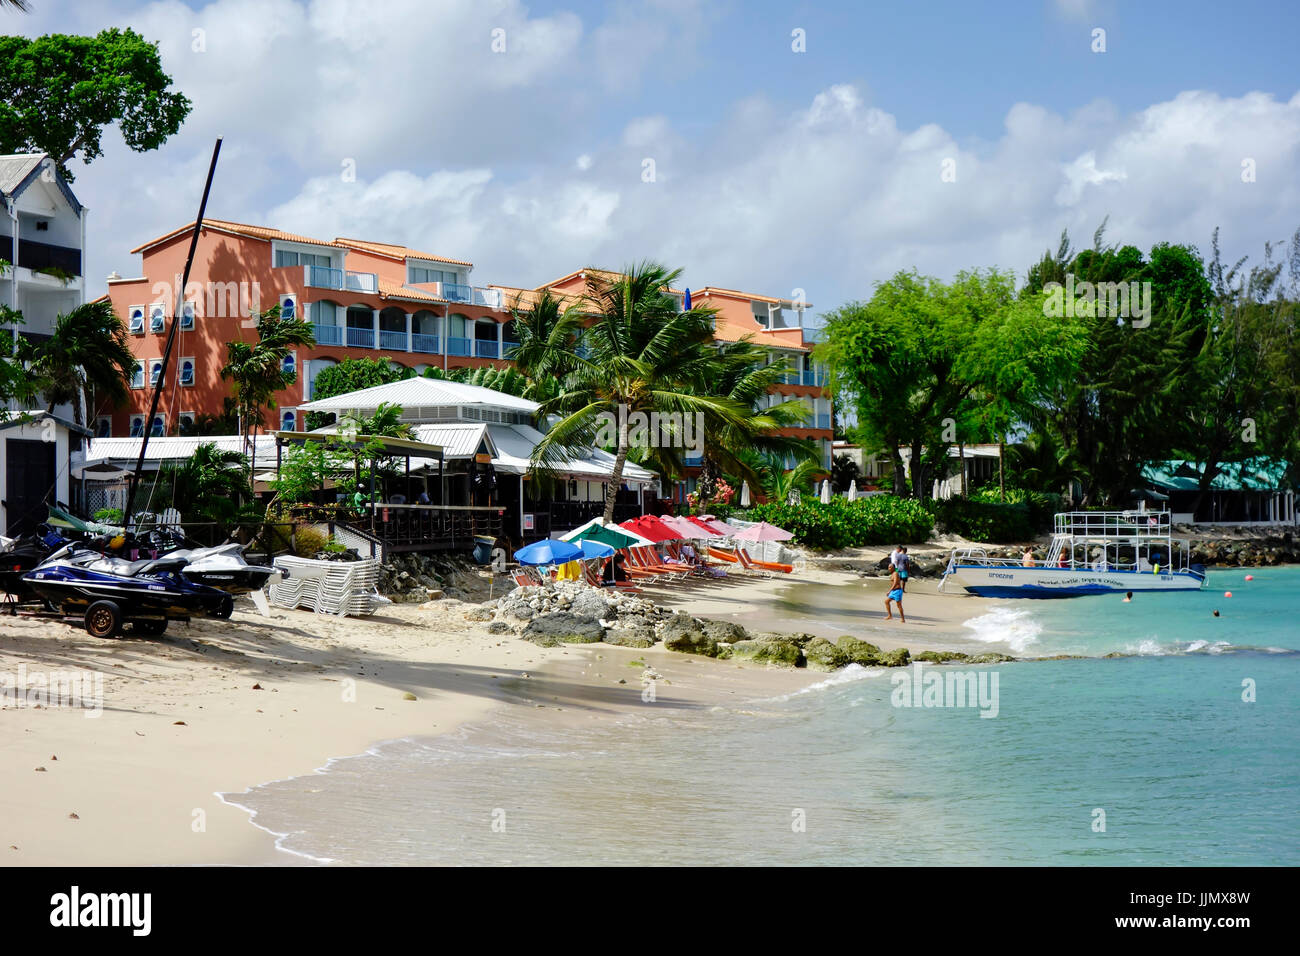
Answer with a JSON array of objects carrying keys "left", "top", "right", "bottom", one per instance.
[{"left": 20, "top": 299, "right": 135, "bottom": 425}]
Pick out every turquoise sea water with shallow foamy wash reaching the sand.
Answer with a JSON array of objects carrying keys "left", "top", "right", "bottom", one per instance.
[{"left": 230, "top": 568, "right": 1300, "bottom": 865}]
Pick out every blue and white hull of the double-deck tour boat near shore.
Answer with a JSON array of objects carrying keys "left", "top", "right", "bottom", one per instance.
[{"left": 944, "top": 564, "right": 1205, "bottom": 597}]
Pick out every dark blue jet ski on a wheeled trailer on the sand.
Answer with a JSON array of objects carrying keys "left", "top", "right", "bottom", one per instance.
[{"left": 22, "top": 541, "right": 234, "bottom": 637}]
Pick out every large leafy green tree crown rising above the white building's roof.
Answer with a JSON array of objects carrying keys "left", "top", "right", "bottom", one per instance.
[{"left": 0, "top": 27, "right": 190, "bottom": 179}]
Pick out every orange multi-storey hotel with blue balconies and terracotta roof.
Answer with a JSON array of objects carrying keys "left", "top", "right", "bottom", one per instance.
[{"left": 101, "top": 219, "right": 831, "bottom": 478}]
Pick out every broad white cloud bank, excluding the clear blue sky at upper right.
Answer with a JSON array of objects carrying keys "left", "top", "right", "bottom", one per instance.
[{"left": 30, "top": 0, "right": 1300, "bottom": 317}]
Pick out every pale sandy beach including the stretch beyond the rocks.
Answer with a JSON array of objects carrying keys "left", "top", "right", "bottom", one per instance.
[{"left": 0, "top": 566, "right": 993, "bottom": 865}]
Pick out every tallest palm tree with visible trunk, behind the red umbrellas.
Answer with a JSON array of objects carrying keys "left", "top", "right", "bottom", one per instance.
[{"left": 533, "top": 263, "right": 748, "bottom": 522}]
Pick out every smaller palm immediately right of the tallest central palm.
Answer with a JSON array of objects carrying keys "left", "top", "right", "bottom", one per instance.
[{"left": 698, "top": 336, "right": 816, "bottom": 502}]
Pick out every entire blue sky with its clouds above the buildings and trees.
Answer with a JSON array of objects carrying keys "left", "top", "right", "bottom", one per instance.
[{"left": 10, "top": 0, "right": 1300, "bottom": 319}]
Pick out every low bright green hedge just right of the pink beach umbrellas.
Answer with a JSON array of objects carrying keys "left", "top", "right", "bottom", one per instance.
[{"left": 742, "top": 494, "right": 933, "bottom": 550}]
